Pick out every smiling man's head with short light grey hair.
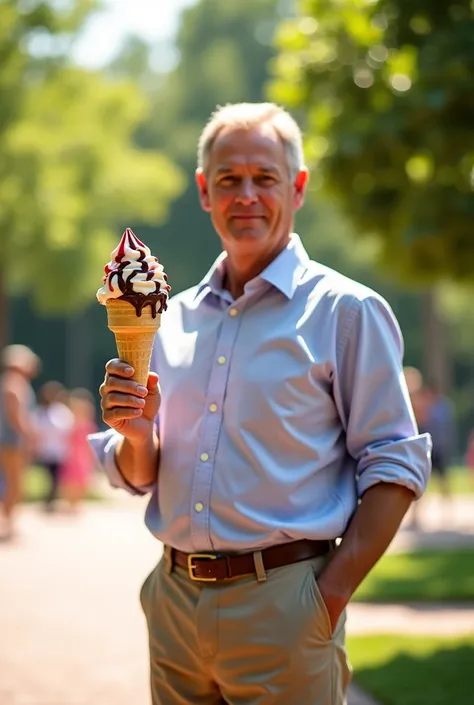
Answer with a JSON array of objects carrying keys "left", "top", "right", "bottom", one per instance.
[{"left": 196, "top": 103, "right": 308, "bottom": 258}]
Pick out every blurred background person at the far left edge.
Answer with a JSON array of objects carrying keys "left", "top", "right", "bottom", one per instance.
[{"left": 0, "top": 345, "right": 40, "bottom": 540}]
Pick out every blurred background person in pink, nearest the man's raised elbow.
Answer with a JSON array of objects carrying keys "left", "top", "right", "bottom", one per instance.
[{"left": 60, "top": 388, "right": 97, "bottom": 512}]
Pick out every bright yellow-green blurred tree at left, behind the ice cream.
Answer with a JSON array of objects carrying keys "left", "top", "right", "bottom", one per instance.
[{"left": 0, "top": 3, "right": 184, "bottom": 348}]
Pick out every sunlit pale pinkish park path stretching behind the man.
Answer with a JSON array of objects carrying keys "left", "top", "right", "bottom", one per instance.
[{"left": 0, "top": 496, "right": 474, "bottom": 705}]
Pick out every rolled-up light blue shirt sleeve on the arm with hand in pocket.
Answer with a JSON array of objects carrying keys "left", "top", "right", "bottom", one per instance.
[{"left": 335, "top": 294, "right": 431, "bottom": 497}]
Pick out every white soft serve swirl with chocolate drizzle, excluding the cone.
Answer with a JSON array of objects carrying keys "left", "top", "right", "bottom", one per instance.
[{"left": 97, "top": 228, "right": 171, "bottom": 318}]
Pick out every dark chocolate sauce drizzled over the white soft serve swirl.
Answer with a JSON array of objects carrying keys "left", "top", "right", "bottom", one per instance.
[{"left": 104, "top": 228, "right": 171, "bottom": 318}]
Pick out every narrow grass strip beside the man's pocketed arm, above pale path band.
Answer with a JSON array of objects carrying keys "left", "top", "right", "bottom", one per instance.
[{"left": 354, "top": 549, "right": 474, "bottom": 604}]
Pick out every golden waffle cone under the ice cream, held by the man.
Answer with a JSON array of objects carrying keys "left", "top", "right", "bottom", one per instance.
[{"left": 106, "top": 299, "right": 161, "bottom": 387}]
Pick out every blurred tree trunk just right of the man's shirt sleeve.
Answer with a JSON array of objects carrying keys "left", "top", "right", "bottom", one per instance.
[{"left": 421, "top": 289, "right": 452, "bottom": 394}]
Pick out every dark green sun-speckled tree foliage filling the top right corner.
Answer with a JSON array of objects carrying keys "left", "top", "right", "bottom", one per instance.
[{"left": 271, "top": 0, "right": 474, "bottom": 283}]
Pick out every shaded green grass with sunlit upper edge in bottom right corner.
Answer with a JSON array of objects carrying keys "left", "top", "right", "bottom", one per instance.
[{"left": 347, "top": 635, "right": 474, "bottom": 705}]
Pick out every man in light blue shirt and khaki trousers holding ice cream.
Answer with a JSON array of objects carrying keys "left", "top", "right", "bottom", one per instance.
[{"left": 92, "top": 104, "right": 430, "bottom": 705}]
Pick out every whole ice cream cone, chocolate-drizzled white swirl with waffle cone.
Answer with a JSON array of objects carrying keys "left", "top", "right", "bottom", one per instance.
[{"left": 97, "top": 228, "right": 170, "bottom": 386}]
